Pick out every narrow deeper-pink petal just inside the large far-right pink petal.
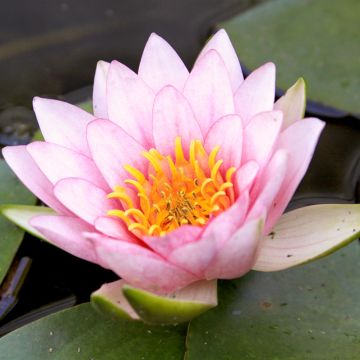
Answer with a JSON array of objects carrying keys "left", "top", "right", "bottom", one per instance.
[{"left": 246, "top": 149, "right": 289, "bottom": 231}]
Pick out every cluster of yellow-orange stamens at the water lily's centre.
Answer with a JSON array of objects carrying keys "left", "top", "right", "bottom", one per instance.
[{"left": 108, "top": 137, "right": 236, "bottom": 238}]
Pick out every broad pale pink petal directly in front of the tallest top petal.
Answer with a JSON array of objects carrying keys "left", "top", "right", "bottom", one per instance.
[{"left": 184, "top": 50, "right": 235, "bottom": 135}]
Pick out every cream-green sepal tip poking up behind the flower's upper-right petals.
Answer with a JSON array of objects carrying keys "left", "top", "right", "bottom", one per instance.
[{"left": 274, "top": 78, "right": 306, "bottom": 129}]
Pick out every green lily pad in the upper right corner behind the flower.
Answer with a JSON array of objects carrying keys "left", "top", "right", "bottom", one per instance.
[{"left": 220, "top": 0, "right": 360, "bottom": 114}]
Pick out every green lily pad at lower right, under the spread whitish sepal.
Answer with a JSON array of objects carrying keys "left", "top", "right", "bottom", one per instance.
[{"left": 186, "top": 242, "right": 360, "bottom": 360}]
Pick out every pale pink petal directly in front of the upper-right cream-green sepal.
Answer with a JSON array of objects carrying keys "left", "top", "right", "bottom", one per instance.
[{"left": 242, "top": 111, "right": 282, "bottom": 168}]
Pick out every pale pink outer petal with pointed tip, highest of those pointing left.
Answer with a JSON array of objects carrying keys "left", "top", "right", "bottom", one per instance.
[{"left": 33, "top": 97, "right": 95, "bottom": 155}]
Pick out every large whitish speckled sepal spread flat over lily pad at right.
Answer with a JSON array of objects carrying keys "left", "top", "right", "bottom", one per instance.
[{"left": 253, "top": 204, "right": 360, "bottom": 271}]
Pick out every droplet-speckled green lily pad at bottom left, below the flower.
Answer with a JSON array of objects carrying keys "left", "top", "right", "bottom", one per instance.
[{"left": 0, "top": 304, "right": 186, "bottom": 360}]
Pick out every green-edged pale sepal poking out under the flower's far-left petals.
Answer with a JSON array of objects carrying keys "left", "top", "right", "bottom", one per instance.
[{"left": 0, "top": 204, "right": 56, "bottom": 240}]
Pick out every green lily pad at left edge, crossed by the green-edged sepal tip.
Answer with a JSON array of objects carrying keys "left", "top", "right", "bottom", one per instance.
[{"left": 0, "top": 160, "right": 36, "bottom": 284}]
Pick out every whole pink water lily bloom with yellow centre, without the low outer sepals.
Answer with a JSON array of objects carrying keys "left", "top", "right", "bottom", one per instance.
[{"left": 3, "top": 30, "right": 324, "bottom": 293}]
